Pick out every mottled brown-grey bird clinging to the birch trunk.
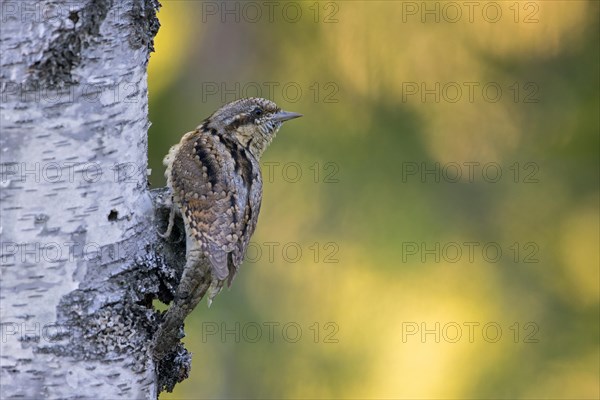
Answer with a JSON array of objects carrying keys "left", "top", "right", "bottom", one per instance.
[{"left": 153, "top": 97, "right": 302, "bottom": 360}]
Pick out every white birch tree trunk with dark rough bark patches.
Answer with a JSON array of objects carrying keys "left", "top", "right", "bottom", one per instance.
[{"left": 0, "top": 0, "right": 181, "bottom": 399}]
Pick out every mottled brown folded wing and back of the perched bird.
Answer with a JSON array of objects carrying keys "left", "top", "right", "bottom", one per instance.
[{"left": 167, "top": 129, "right": 249, "bottom": 280}]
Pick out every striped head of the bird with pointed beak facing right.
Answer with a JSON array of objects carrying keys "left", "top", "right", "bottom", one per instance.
[{"left": 205, "top": 97, "right": 302, "bottom": 159}]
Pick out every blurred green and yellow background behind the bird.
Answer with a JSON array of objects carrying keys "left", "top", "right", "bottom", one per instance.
[{"left": 149, "top": 0, "right": 600, "bottom": 399}]
